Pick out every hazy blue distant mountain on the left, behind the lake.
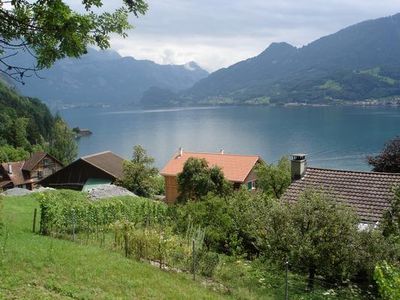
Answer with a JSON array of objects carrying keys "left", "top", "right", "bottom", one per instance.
[{"left": 13, "top": 49, "right": 208, "bottom": 105}]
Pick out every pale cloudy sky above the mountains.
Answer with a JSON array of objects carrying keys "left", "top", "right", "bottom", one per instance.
[{"left": 67, "top": 0, "right": 400, "bottom": 72}]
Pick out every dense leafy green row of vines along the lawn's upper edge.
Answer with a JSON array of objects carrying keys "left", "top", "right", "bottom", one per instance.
[{"left": 40, "top": 190, "right": 167, "bottom": 236}]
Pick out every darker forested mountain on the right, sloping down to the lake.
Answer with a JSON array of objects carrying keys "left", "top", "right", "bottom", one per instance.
[{"left": 180, "top": 14, "right": 400, "bottom": 104}]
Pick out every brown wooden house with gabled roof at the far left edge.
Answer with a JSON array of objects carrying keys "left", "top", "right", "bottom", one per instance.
[{"left": 0, "top": 152, "right": 63, "bottom": 190}]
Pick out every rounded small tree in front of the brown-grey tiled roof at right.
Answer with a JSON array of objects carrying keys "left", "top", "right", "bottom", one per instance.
[{"left": 290, "top": 191, "right": 358, "bottom": 289}]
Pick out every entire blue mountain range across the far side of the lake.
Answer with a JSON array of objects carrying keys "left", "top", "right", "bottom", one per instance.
[{"left": 8, "top": 14, "right": 400, "bottom": 106}]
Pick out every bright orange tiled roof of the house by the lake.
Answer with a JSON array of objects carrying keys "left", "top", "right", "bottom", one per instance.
[{"left": 160, "top": 152, "right": 261, "bottom": 182}]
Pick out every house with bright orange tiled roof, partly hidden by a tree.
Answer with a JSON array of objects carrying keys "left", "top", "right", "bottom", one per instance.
[{"left": 160, "top": 148, "right": 262, "bottom": 203}]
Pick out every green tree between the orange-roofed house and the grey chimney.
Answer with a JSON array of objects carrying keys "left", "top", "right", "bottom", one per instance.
[{"left": 256, "top": 156, "right": 291, "bottom": 199}]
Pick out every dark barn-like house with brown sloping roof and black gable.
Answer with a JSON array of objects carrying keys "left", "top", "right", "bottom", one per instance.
[{"left": 40, "top": 151, "right": 124, "bottom": 190}]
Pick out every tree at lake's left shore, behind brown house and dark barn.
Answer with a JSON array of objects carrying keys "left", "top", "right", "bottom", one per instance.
[{"left": 47, "top": 117, "right": 78, "bottom": 165}]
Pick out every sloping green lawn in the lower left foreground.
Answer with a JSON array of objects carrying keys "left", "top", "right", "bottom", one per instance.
[{"left": 0, "top": 197, "right": 227, "bottom": 299}]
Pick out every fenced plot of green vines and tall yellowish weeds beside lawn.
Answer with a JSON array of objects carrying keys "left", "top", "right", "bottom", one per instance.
[{"left": 39, "top": 190, "right": 218, "bottom": 276}]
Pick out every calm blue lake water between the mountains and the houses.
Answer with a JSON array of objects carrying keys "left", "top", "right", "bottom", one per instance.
[{"left": 61, "top": 107, "right": 400, "bottom": 170}]
